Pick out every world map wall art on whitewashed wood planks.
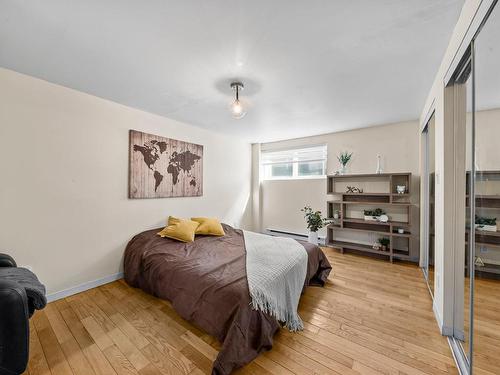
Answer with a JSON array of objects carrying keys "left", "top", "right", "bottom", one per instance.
[{"left": 129, "top": 130, "right": 203, "bottom": 198}]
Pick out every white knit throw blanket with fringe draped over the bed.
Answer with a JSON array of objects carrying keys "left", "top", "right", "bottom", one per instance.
[{"left": 243, "top": 231, "right": 307, "bottom": 332}]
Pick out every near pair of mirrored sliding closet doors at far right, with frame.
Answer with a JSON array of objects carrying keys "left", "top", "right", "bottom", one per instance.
[{"left": 451, "top": 4, "right": 500, "bottom": 374}]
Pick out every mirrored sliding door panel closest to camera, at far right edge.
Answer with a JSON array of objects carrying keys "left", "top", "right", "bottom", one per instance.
[{"left": 468, "top": 5, "right": 500, "bottom": 374}]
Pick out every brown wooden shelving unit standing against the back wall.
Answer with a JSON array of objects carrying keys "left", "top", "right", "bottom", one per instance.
[{"left": 326, "top": 173, "right": 413, "bottom": 262}]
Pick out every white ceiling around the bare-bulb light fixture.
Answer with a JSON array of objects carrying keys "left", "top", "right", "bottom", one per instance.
[{"left": 0, "top": 0, "right": 464, "bottom": 142}]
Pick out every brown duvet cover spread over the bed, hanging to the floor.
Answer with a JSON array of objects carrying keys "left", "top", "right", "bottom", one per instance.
[{"left": 124, "top": 225, "right": 331, "bottom": 374}]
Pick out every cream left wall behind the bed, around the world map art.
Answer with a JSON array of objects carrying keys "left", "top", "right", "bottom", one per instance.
[{"left": 0, "top": 69, "right": 252, "bottom": 294}]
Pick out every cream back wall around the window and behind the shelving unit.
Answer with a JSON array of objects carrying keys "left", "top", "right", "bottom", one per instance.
[{"left": 261, "top": 121, "right": 419, "bottom": 256}]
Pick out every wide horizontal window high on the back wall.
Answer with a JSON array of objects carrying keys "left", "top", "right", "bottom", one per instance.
[{"left": 262, "top": 145, "right": 326, "bottom": 180}]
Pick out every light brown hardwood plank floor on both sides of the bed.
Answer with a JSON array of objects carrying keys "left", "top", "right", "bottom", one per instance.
[{"left": 27, "top": 249, "right": 457, "bottom": 375}]
